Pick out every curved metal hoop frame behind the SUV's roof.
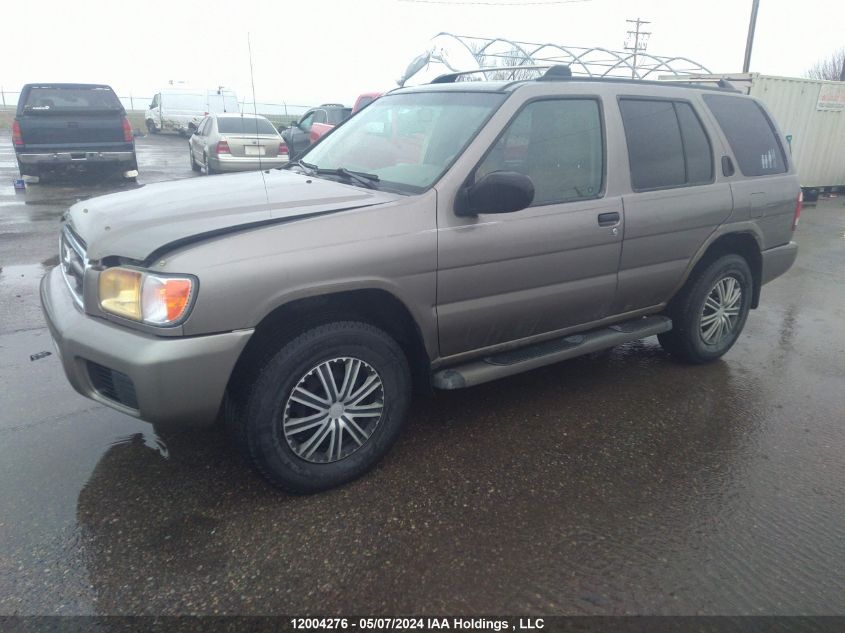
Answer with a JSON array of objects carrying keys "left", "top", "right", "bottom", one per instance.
[{"left": 432, "top": 32, "right": 710, "bottom": 79}]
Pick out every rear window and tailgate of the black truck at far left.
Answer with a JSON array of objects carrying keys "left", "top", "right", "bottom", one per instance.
[{"left": 17, "top": 85, "right": 126, "bottom": 151}]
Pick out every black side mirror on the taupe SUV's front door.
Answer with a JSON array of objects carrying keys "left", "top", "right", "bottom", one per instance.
[{"left": 455, "top": 171, "right": 534, "bottom": 216}]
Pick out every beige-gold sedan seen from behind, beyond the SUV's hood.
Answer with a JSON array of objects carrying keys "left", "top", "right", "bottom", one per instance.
[{"left": 188, "top": 114, "right": 288, "bottom": 174}]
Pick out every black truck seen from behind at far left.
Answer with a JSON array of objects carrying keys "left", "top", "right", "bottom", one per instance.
[{"left": 12, "top": 83, "right": 138, "bottom": 182}]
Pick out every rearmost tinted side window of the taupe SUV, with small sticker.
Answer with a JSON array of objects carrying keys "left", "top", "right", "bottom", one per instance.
[{"left": 704, "top": 95, "right": 786, "bottom": 176}]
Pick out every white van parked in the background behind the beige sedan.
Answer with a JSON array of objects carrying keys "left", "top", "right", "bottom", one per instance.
[{"left": 144, "top": 87, "right": 240, "bottom": 136}]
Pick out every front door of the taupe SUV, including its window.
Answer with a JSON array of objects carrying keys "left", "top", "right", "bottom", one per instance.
[{"left": 437, "top": 97, "right": 624, "bottom": 357}]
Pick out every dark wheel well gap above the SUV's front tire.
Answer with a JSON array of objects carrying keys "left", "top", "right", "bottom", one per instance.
[{"left": 227, "top": 288, "right": 431, "bottom": 394}]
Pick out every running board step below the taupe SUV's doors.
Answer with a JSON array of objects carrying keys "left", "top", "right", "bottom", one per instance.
[{"left": 432, "top": 316, "right": 672, "bottom": 389}]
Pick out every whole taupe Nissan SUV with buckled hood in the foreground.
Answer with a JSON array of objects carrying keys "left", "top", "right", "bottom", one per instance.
[{"left": 41, "top": 68, "right": 801, "bottom": 493}]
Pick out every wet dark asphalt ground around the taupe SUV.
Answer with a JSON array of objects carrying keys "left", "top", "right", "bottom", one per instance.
[{"left": 0, "top": 131, "right": 845, "bottom": 615}]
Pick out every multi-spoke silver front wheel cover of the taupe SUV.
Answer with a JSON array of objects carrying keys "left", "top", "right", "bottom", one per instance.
[{"left": 282, "top": 357, "right": 384, "bottom": 464}]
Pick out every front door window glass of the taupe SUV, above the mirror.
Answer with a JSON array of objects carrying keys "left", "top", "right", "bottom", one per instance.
[{"left": 475, "top": 99, "right": 604, "bottom": 207}]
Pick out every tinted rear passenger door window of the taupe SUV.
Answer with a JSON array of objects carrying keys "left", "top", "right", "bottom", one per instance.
[{"left": 619, "top": 99, "right": 713, "bottom": 191}]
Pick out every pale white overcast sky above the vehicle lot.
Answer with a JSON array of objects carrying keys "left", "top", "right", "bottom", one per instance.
[{"left": 0, "top": 0, "right": 845, "bottom": 105}]
